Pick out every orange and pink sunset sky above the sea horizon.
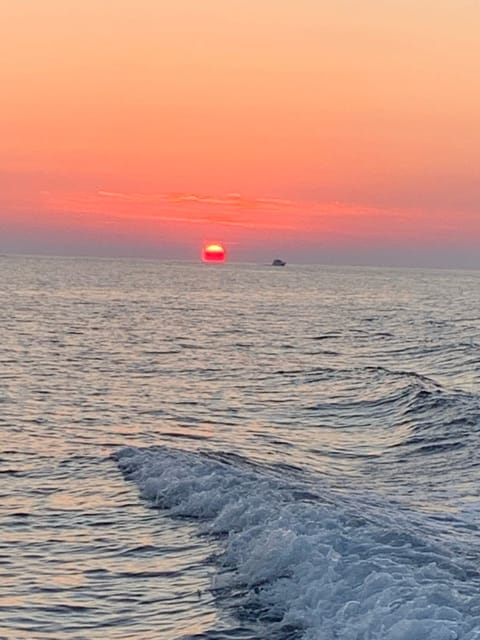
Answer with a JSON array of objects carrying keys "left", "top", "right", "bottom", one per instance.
[{"left": 0, "top": 0, "right": 480, "bottom": 268}]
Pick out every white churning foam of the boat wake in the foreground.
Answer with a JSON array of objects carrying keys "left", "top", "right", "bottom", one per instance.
[{"left": 117, "top": 448, "right": 480, "bottom": 640}]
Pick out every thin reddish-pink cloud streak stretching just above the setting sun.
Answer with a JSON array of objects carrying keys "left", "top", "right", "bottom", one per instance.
[{"left": 31, "top": 189, "right": 480, "bottom": 244}]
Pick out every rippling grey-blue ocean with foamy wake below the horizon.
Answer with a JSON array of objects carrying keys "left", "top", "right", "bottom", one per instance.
[{"left": 0, "top": 256, "right": 480, "bottom": 640}]
